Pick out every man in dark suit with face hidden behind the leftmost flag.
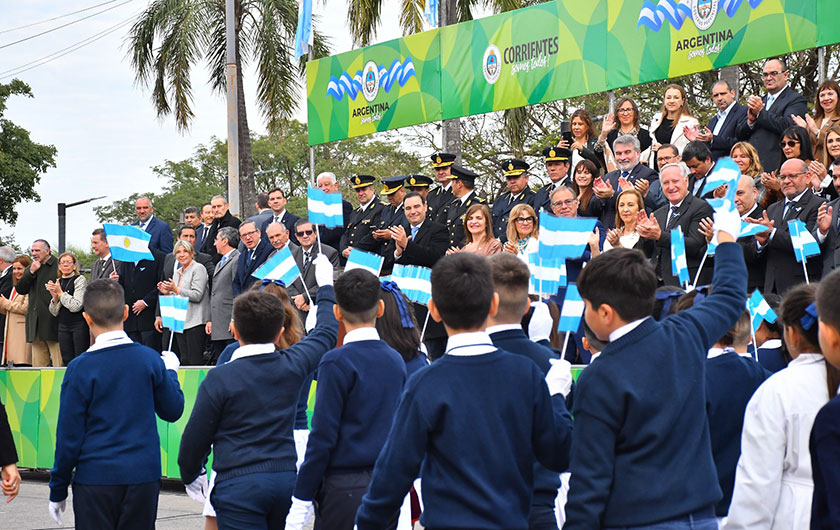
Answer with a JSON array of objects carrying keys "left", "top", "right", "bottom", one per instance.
[{"left": 118, "top": 249, "right": 164, "bottom": 351}]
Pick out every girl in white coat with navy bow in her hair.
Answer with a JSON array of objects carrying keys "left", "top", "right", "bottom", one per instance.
[{"left": 723, "top": 284, "right": 837, "bottom": 530}]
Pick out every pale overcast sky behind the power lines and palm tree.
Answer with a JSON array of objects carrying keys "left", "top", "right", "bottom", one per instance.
[{"left": 0, "top": 0, "right": 399, "bottom": 249}]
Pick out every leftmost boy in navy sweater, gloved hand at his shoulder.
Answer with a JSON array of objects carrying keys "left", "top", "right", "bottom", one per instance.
[{"left": 50, "top": 280, "right": 184, "bottom": 530}]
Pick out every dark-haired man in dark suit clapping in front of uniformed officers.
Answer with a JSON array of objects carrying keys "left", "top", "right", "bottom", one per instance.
[{"left": 391, "top": 192, "right": 449, "bottom": 360}]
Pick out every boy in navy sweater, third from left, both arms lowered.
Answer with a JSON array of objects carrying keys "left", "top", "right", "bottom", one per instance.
[{"left": 286, "top": 269, "right": 405, "bottom": 530}]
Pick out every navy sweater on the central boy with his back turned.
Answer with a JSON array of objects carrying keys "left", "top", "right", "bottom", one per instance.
[{"left": 356, "top": 350, "right": 572, "bottom": 530}]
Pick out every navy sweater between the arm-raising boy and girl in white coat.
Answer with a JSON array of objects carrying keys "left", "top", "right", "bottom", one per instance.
[{"left": 706, "top": 351, "right": 770, "bottom": 517}]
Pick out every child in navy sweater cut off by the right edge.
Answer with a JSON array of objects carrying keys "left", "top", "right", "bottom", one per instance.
[{"left": 809, "top": 271, "right": 840, "bottom": 530}]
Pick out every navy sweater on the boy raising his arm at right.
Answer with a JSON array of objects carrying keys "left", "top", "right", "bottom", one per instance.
[{"left": 563, "top": 243, "right": 747, "bottom": 530}]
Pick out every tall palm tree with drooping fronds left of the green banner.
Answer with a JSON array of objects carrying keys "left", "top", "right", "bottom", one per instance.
[{"left": 128, "top": 0, "right": 329, "bottom": 216}]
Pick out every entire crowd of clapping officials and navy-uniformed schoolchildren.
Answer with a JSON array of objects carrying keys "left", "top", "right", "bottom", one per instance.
[{"left": 0, "top": 55, "right": 840, "bottom": 530}]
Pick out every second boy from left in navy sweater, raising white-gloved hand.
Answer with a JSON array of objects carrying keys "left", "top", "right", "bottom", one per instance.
[{"left": 178, "top": 256, "right": 338, "bottom": 529}]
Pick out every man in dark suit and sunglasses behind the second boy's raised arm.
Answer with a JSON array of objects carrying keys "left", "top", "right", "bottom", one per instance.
[{"left": 287, "top": 219, "right": 339, "bottom": 322}]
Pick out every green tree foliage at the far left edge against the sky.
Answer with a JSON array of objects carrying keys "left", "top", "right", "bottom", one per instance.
[{"left": 0, "top": 79, "right": 56, "bottom": 224}]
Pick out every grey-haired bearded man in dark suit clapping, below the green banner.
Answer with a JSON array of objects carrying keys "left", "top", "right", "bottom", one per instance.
[{"left": 592, "top": 134, "right": 664, "bottom": 229}]
